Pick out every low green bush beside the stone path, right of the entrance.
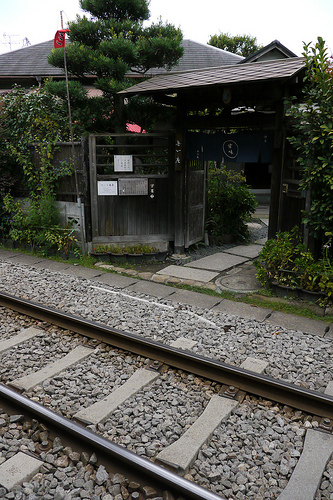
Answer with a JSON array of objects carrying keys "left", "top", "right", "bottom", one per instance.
[{"left": 255, "top": 228, "right": 333, "bottom": 299}]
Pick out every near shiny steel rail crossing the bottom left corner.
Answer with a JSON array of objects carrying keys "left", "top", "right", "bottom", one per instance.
[{"left": 0, "top": 383, "right": 224, "bottom": 500}]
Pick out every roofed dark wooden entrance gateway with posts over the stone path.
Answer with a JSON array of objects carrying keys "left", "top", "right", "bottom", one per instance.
[{"left": 119, "top": 54, "right": 305, "bottom": 253}]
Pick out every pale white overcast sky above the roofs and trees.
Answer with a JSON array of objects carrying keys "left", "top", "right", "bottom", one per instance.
[{"left": 0, "top": 0, "right": 333, "bottom": 56}]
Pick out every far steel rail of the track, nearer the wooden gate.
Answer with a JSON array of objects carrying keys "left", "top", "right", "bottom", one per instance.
[{"left": 0, "top": 293, "right": 333, "bottom": 419}]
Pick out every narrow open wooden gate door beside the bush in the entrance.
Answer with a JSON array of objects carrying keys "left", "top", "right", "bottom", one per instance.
[{"left": 185, "top": 155, "right": 206, "bottom": 248}]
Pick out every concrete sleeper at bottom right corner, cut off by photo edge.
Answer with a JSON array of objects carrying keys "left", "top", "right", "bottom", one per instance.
[{"left": 277, "top": 429, "right": 333, "bottom": 500}]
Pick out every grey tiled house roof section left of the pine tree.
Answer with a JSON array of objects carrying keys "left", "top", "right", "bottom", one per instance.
[{"left": 0, "top": 40, "right": 65, "bottom": 78}]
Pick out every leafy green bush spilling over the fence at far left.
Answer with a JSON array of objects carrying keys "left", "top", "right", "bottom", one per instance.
[{"left": 0, "top": 86, "right": 72, "bottom": 197}]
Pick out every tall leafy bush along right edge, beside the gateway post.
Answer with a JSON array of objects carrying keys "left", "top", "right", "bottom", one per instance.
[{"left": 288, "top": 37, "right": 333, "bottom": 244}]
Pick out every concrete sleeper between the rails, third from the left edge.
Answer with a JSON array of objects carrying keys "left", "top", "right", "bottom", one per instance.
[{"left": 74, "top": 369, "right": 160, "bottom": 424}]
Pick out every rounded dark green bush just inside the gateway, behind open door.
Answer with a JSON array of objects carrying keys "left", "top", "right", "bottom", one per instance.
[{"left": 206, "top": 167, "right": 258, "bottom": 244}]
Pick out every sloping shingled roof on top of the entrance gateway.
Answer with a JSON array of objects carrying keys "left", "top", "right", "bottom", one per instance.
[{"left": 119, "top": 57, "right": 305, "bottom": 96}]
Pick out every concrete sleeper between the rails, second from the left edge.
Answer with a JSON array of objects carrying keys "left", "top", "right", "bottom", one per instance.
[{"left": 8, "top": 346, "right": 93, "bottom": 391}]
